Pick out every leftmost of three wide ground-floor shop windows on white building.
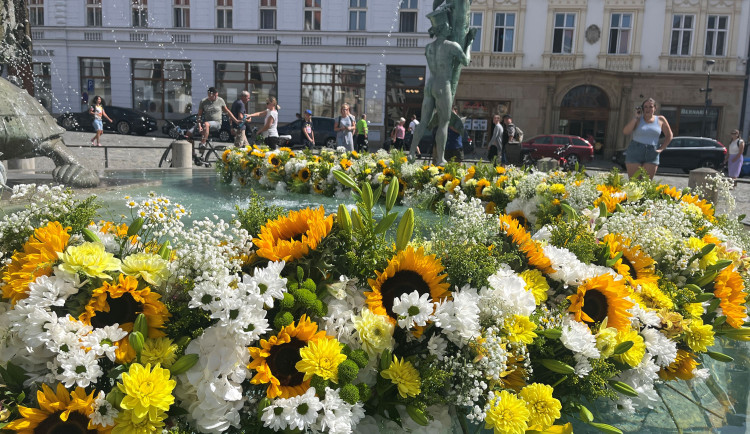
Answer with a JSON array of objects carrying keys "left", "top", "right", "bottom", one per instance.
[{"left": 130, "top": 59, "right": 192, "bottom": 119}]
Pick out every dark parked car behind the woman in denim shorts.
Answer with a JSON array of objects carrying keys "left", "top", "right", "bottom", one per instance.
[{"left": 613, "top": 136, "right": 727, "bottom": 173}]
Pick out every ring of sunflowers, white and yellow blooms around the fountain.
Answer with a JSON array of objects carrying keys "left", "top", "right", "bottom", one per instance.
[{"left": 0, "top": 160, "right": 750, "bottom": 433}]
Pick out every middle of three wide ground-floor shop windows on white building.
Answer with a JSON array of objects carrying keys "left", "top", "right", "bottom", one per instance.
[{"left": 215, "top": 61, "right": 277, "bottom": 113}]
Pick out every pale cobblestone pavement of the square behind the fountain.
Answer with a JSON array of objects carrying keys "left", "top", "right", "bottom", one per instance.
[{"left": 9, "top": 132, "right": 750, "bottom": 225}]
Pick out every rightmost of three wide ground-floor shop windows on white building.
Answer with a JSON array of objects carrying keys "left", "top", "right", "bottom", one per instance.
[{"left": 301, "top": 63, "right": 365, "bottom": 117}]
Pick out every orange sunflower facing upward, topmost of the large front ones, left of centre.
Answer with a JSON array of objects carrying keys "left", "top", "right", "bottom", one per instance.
[{"left": 253, "top": 206, "right": 333, "bottom": 262}]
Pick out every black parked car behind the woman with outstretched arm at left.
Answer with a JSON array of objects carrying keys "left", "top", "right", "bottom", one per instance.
[{"left": 57, "top": 105, "right": 156, "bottom": 136}]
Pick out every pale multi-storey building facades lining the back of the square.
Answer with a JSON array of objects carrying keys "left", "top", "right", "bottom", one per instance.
[{"left": 28, "top": 0, "right": 750, "bottom": 156}]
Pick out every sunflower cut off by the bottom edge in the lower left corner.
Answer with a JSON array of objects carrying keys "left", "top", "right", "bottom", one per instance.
[{"left": 4, "top": 383, "right": 112, "bottom": 434}]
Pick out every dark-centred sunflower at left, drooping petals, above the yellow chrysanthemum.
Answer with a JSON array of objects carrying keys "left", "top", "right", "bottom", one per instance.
[{"left": 78, "top": 274, "right": 171, "bottom": 363}]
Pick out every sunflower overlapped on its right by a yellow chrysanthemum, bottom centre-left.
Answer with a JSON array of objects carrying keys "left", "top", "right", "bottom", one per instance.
[{"left": 247, "top": 315, "right": 332, "bottom": 398}]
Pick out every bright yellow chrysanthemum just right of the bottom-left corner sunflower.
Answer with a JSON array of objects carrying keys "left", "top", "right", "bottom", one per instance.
[{"left": 117, "top": 363, "right": 177, "bottom": 423}]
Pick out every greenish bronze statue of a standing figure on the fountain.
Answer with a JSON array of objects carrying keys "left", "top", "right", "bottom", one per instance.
[{"left": 410, "top": 0, "right": 474, "bottom": 165}]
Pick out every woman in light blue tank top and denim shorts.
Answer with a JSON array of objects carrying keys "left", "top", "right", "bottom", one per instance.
[{"left": 622, "top": 98, "right": 672, "bottom": 179}]
